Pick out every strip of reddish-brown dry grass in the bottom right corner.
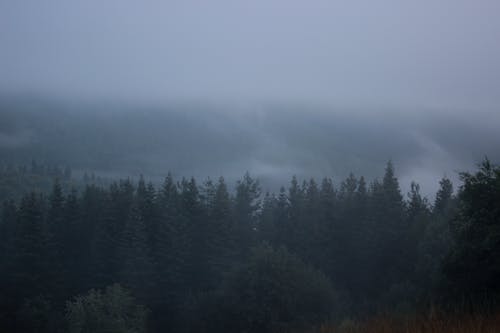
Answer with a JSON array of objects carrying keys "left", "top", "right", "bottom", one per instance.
[{"left": 310, "top": 312, "right": 500, "bottom": 333}]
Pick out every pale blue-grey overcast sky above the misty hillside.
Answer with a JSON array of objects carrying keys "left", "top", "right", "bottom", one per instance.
[{"left": 0, "top": 0, "right": 500, "bottom": 110}]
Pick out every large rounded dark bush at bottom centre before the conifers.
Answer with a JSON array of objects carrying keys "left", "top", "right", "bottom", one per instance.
[{"left": 189, "top": 245, "right": 337, "bottom": 333}]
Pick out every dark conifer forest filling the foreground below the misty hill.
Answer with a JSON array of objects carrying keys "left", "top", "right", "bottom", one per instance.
[{"left": 0, "top": 159, "right": 500, "bottom": 333}]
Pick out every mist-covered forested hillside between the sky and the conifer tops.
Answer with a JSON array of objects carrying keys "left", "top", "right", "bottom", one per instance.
[{"left": 0, "top": 95, "right": 500, "bottom": 196}]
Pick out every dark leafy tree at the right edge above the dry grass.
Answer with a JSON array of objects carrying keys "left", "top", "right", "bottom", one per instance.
[{"left": 443, "top": 159, "right": 500, "bottom": 300}]
